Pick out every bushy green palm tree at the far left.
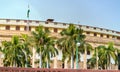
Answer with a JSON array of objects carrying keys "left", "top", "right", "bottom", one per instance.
[{"left": 1, "top": 36, "right": 25, "bottom": 67}]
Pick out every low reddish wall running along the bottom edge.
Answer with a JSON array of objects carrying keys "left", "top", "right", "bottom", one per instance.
[{"left": 0, "top": 67, "right": 119, "bottom": 72}]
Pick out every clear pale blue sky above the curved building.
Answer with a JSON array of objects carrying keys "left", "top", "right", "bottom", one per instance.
[{"left": 0, "top": 0, "right": 120, "bottom": 31}]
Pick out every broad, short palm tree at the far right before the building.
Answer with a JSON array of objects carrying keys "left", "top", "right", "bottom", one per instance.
[{"left": 90, "top": 42, "right": 118, "bottom": 69}]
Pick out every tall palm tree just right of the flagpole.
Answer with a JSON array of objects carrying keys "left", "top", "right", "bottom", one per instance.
[{"left": 32, "top": 26, "right": 57, "bottom": 68}]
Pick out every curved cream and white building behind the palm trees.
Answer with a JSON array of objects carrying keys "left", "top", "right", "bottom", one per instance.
[{"left": 0, "top": 19, "right": 120, "bottom": 69}]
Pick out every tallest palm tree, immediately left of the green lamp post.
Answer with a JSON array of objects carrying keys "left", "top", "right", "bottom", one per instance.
[{"left": 59, "top": 24, "right": 85, "bottom": 68}]
